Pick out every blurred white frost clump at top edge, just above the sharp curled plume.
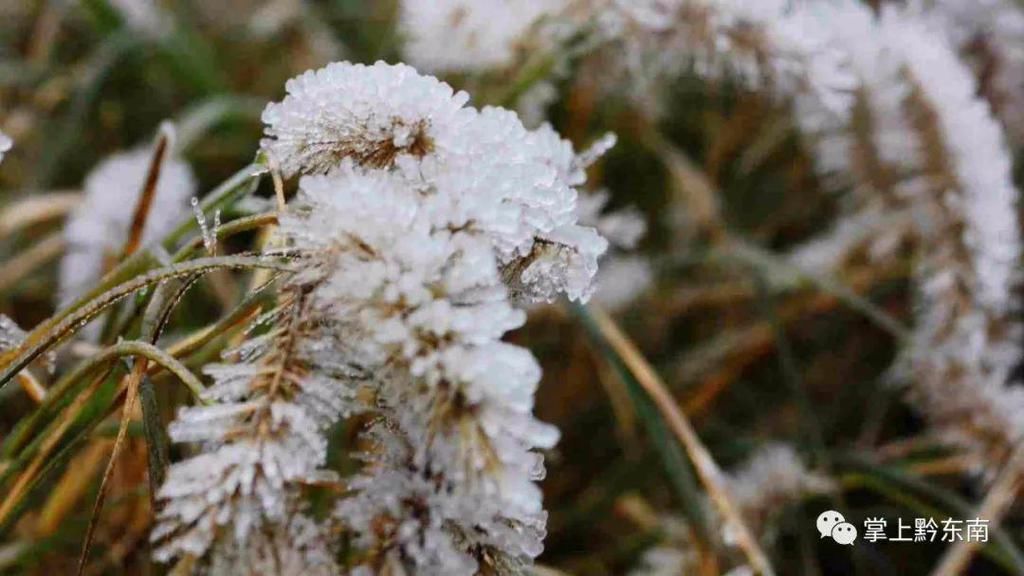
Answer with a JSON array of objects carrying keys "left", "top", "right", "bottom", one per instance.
[{"left": 399, "top": 0, "right": 569, "bottom": 74}]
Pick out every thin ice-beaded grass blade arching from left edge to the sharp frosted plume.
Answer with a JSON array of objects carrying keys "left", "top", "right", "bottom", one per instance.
[{"left": 0, "top": 255, "right": 291, "bottom": 387}]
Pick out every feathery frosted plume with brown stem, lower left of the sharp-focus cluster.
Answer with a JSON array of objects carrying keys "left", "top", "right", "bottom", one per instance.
[{"left": 151, "top": 277, "right": 353, "bottom": 574}]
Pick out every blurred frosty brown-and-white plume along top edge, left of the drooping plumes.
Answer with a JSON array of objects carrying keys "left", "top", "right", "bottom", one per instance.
[{"left": 597, "top": 0, "right": 849, "bottom": 112}]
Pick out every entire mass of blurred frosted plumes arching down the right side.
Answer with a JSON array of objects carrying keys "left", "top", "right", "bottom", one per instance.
[{"left": 593, "top": 0, "right": 1024, "bottom": 473}]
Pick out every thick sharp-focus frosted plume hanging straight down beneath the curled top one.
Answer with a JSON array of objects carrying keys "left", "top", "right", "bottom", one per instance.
[{"left": 281, "top": 163, "right": 557, "bottom": 574}]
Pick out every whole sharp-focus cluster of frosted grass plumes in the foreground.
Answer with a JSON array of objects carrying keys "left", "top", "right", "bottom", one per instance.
[{"left": 153, "top": 63, "right": 606, "bottom": 575}]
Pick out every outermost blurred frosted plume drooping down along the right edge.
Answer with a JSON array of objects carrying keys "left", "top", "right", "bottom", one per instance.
[{"left": 881, "top": 10, "right": 1024, "bottom": 467}]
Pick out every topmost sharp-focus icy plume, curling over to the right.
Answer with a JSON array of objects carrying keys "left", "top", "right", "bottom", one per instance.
[{"left": 263, "top": 63, "right": 606, "bottom": 300}]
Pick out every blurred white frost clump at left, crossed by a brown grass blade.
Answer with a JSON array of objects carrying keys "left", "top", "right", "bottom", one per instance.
[{"left": 60, "top": 149, "right": 197, "bottom": 303}]
